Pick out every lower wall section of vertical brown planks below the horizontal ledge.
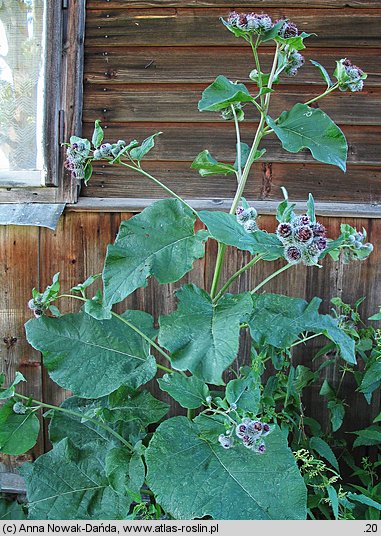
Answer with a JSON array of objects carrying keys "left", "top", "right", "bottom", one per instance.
[{"left": 0, "top": 211, "right": 381, "bottom": 464}]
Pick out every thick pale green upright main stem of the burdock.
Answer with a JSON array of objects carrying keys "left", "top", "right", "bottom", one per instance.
[{"left": 211, "top": 44, "right": 279, "bottom": 298}]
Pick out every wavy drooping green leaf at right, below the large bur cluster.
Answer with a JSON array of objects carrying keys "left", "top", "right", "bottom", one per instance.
[{"left": 249, "top": 294, "right": 356, "bottom": 364}]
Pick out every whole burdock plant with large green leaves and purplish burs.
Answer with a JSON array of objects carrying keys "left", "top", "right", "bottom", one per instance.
[{"left": 0, "top": 11, "right": 375, "bottom": 519}]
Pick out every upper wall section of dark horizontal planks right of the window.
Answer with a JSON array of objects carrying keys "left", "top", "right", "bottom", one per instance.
[{"left": 82, "top": 0, "right": 381, "bottom": 203}]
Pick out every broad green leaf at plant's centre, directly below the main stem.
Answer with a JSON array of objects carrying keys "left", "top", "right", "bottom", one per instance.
[{"left": 159, "top": 285, "right": 252, "bottom": 385}]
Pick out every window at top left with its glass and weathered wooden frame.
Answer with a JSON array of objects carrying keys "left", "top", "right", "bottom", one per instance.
[{"left": 0, "top": 0, "right": 85, "bottom": 202}]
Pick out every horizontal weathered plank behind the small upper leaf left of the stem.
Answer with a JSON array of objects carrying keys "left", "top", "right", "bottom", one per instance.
[{"left": 83, "top": 84, "right": 381, "bottom": 126}]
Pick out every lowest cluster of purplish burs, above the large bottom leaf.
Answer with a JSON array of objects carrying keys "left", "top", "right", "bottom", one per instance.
[{"left": 218, "top": 417, "right": 272, "bottom": 454}]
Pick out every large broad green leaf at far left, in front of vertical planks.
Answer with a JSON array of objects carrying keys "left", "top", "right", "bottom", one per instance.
[{"left": 25, "top": 311, "right": 156, "bottom": 398}]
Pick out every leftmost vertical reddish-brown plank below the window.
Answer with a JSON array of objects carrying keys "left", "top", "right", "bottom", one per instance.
[{"left": 0, "top": 226, "right": 43, "bottom": 470}]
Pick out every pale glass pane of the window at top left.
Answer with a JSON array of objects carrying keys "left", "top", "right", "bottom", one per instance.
[{"left": 0, "top": 0, "right": 46, "bottom": 185}]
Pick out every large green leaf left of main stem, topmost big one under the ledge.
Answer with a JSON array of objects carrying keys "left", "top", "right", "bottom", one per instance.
[{"left": 103, "top": 199, "right": 208, "bottom": 306}]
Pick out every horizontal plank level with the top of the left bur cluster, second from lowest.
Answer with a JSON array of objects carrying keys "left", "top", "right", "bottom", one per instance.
[{"left": 83, "top": 120, "right": 381, "bottom": 165}]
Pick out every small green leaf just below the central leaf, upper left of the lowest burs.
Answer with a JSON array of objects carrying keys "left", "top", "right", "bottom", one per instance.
[{"left": 157, "top": 374, "right": 209, "bottom": 409}]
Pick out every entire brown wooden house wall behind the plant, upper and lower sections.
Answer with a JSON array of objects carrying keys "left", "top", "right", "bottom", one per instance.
[{"left": 0, "top": 0, "right": 381, "bottom": 474}]
